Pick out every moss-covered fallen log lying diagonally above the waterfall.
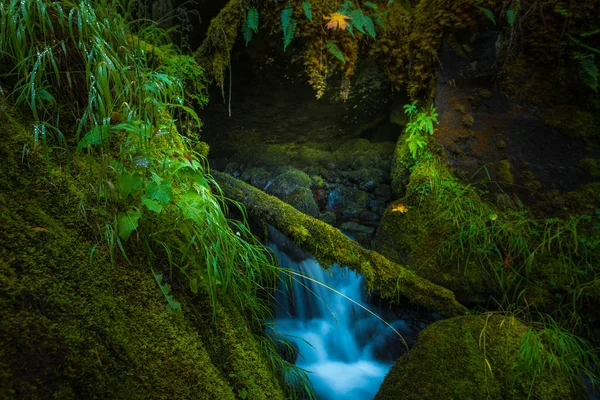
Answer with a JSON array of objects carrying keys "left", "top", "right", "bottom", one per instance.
[{"left": 213, "top": 171, "right": 467, "bottom": 316}]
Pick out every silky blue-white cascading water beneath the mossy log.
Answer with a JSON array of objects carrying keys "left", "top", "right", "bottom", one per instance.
[{"left": 269, "top": 229, "right": 416, "bottom": 400}]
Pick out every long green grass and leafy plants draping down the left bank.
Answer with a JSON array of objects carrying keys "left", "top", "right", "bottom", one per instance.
[{"left": 0, "top": 0, "right": 314, "bottom": 396}]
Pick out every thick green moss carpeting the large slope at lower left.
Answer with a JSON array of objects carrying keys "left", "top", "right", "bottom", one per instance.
[{"left": 0, "top": 107, "right": 284, "bottom": 399}]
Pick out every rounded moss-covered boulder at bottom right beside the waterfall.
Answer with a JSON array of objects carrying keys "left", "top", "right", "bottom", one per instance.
[{"left": 375, "top": 314, "right": 580, "bottom": 400}]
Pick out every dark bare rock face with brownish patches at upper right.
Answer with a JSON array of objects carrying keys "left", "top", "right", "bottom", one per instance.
[{"left": 435, "top": 31, "right": 600, "bottom": 203}]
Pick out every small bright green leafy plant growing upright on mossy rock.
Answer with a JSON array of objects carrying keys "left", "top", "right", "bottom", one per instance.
[{"left": 404, "top": 101, "right": 438, "bottom": 160}]
